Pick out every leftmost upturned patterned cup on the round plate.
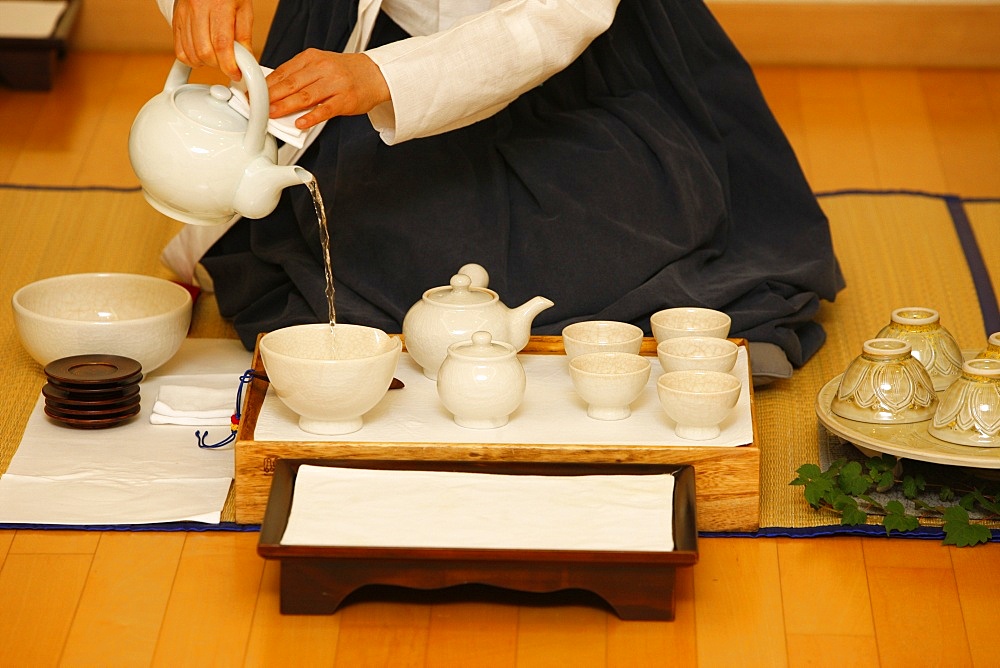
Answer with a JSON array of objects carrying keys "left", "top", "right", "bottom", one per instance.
[{"left": 831, "top": 338, "right": 938, "bottom": 424}]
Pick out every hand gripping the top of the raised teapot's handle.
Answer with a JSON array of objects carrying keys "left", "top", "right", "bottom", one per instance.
[{"left": 173, "top": 0, "right": 253, "bottom": 81}]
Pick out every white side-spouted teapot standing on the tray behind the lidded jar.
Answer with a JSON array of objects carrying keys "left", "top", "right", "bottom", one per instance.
[{"left": 403, "top": 265, "right": 555, "bottom": 380}]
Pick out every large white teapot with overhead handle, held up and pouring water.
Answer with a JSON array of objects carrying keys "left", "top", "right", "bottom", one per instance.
[{"left": 128, "top": 44, "right": 312, "bottom": 225}]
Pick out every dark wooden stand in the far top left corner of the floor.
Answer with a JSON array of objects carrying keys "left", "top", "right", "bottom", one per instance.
[{"left": 0, "top": 0, "right": 81, "bottom": 90}]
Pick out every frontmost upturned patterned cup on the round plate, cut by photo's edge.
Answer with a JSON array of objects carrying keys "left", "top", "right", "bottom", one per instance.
[{"left": 927, "top": 358, "right": 1000, "bottom": 447}]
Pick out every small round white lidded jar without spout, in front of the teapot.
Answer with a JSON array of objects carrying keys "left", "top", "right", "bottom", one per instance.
[{"left": 437, "top": 331, "right": 526, "bottom": 429}]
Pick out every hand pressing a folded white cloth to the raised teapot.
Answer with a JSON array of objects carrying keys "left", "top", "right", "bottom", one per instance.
[{"left": 267, "top": 49, "right": 390, "bottom": 130}]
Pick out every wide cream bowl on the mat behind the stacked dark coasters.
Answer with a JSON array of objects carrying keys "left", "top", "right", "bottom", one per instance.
[{"left": 11, "top": 273, "right": 192, "bottom": 373}]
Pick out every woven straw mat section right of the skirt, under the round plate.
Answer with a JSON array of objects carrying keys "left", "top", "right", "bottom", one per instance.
[{"left": 752, "top": 190, "right": 1000, "bottom": 541}]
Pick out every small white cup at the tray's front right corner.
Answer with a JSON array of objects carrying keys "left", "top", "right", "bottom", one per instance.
[{"left": 656, "top": 370, "right": 742, "bottom": 441}]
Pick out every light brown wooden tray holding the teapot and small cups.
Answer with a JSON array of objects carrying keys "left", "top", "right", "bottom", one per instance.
[{"left": 234, "top": 336, "right": 760, "bottom": 531}]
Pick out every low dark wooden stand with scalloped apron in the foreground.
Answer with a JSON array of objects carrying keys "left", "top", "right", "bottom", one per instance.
[{"left": 257, "top": 460, "right": 698, "bottom": 620}]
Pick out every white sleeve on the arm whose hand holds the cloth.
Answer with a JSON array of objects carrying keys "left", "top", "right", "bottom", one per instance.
[{"left": 365, "top": 0, "right": 618, "bottom": 145}]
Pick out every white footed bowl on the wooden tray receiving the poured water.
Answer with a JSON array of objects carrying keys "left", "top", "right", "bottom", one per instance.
[{"left": 259, "top": 323, "right": 402, "bottom": 435}]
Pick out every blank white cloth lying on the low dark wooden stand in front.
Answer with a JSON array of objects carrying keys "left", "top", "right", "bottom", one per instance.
[{"left": 281, "top": 466, "right": 674, "bottom": 552}]
